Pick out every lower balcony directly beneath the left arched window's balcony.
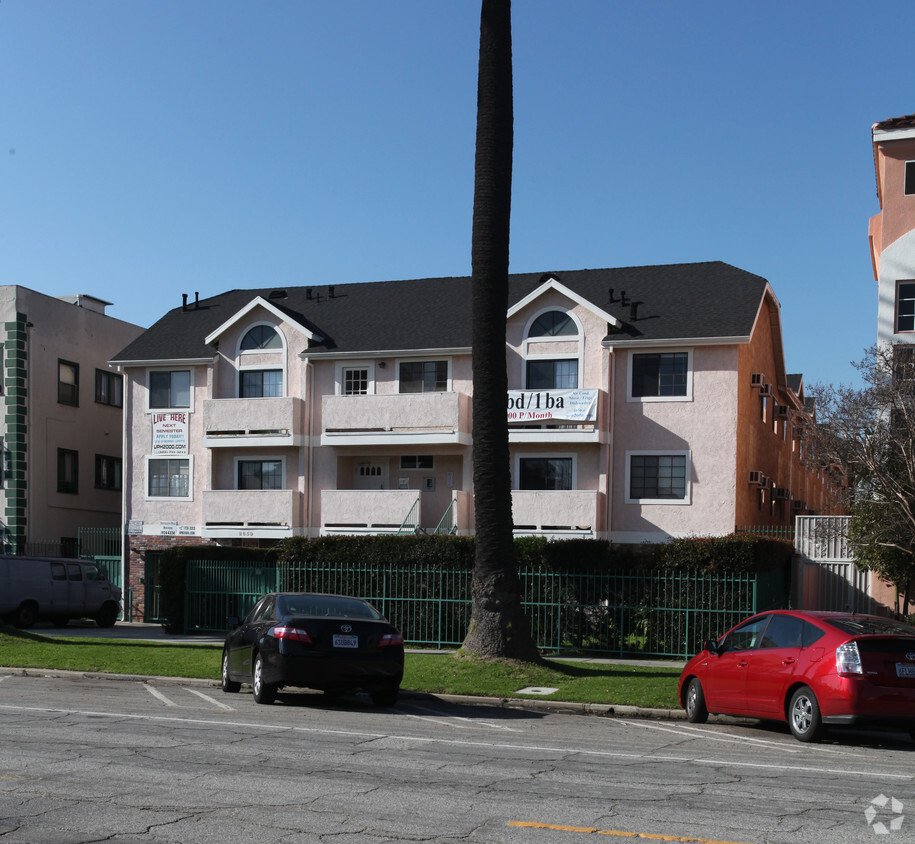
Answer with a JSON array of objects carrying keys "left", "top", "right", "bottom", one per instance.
[{"left": 202, "top": 489, "right": 302, "bottom": 538}]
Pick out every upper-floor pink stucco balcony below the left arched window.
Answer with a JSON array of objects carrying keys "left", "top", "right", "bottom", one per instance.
[{"left": 203, "top": 396, "right": 305, "bottom": 448}]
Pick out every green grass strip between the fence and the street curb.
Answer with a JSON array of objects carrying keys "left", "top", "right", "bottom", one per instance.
[{"left": 0, "top": 627, "right": 680, "bottom": 709}]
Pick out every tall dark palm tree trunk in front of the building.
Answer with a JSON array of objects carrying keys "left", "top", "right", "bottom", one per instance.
[{"left": 463, "top": 0, "right": 540, "bottom": 661}]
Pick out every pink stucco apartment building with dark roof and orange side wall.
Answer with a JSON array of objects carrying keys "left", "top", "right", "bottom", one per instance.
[{"left": 111, "top": 262, "right": 829, "bottom": 620}]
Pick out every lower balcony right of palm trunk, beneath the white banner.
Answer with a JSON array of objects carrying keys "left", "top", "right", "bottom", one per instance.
[{"left": 512, "top": 489, "right": 605, "bottom": 538}]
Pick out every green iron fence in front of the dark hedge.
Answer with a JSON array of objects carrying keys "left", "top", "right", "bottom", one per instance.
[{"left": 185, "top": 561, "right": 786, "bottom": 657}]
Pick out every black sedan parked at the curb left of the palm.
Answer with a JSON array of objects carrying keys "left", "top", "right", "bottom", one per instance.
[{"left": 222, "top": 592, "right": 403, "bottom": 706}]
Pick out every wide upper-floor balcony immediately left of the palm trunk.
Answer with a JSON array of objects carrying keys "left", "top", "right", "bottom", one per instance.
[{"left": 321, "top": 393, "right": 472, "bottom": 448}]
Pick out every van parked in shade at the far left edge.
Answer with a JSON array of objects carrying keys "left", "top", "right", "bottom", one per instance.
[{"left": 0, "top": 555, "right": 121, "bottom": 627}]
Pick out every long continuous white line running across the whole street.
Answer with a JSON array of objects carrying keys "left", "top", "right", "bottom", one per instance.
[{"left": 0, "top": 703, "right": 915, "bottom": 782}]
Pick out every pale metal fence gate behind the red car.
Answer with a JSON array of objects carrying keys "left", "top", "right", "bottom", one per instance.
[{"left": 791, "top": 516, "right": 873, "bottom": 613}]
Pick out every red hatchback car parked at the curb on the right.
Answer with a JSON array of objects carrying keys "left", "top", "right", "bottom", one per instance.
[{"left": 678, "top": 610, "right": 915, "bottom": 741}]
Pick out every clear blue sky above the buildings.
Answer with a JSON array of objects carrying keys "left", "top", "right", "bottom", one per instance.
[{"left": 0, "top": 0, "right": 915, "bottom": 384}]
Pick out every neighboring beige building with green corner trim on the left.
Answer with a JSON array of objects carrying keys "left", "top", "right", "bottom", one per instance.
[{"left": 0, "top": 285, "right": 144, "bottom": 554}]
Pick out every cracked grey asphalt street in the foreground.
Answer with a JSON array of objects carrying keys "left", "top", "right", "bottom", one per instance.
[{"left": 0, "top": 670, "right": 915, "bottom": 844}]
